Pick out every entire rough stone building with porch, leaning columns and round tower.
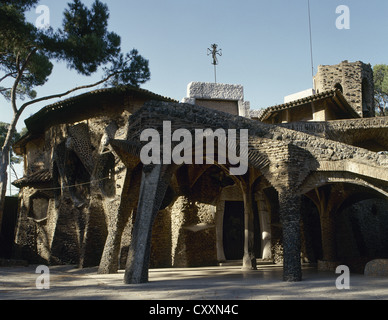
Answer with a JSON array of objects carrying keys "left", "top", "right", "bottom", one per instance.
[{"left": 9, "top": 62, "right": 388, "bottom": 283}]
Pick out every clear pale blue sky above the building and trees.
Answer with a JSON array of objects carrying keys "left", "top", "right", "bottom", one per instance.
[{"left": 0, "top": 0, "right": 388, "bottom": 127}]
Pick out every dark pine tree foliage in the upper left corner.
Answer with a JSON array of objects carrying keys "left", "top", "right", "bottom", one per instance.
[{"left": 0, "top": 0, "right": 150, "bottom": 100}]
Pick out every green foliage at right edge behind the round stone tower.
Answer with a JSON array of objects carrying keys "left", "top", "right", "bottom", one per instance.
[{"left": 373, "top": 64, "right": 388, "bottom": 116}]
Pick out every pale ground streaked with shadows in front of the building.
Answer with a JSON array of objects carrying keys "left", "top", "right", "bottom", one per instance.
[{"left": 0, "top": 266, "right": 388, "bottom": 301}]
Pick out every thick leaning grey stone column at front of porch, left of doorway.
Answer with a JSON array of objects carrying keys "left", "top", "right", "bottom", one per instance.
[{"left": 124, "top": 165, "right": 172, "bottom": 284}]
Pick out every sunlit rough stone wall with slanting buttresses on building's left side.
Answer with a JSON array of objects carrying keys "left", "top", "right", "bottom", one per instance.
[{"left": 14, "top": 97, "right": 147, "bottom": 267}]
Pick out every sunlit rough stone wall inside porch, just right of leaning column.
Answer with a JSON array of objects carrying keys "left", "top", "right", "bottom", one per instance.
[{"left": 151, "top": 168, "right": 221, "bottom": 267}]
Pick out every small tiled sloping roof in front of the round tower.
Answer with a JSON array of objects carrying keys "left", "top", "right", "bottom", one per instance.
[{"left": 258, "top": 89, "right": 360, "bottom": 121}]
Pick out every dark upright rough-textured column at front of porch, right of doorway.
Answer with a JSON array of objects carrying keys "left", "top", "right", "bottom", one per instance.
[{"left": 279, "top": 190, "right": 302, "bottom": 282}]
